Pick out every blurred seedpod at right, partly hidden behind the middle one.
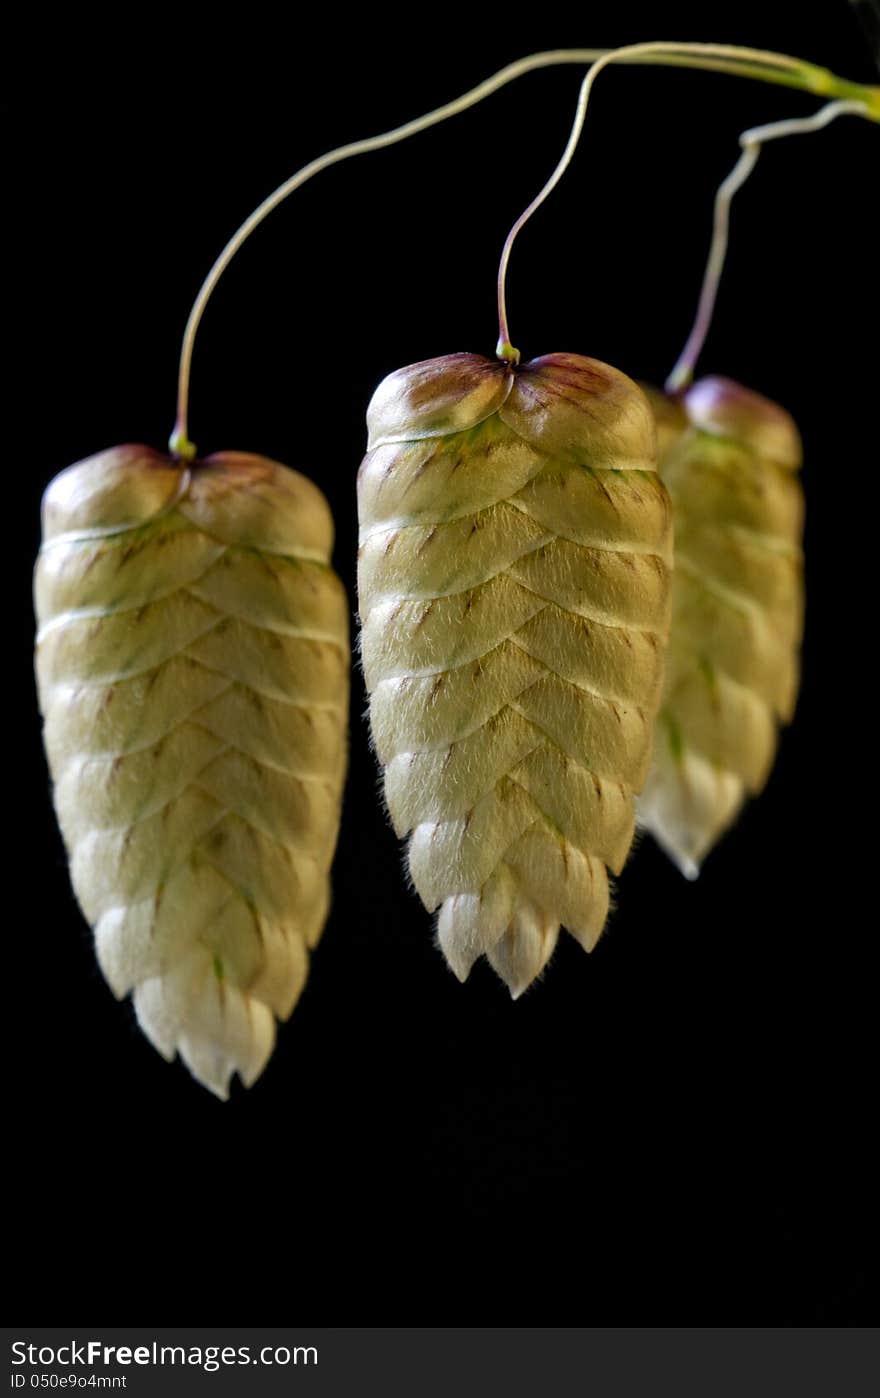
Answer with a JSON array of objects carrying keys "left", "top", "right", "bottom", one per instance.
[{"left": 639, "top": 377, "right": 803, "bottom": 878}]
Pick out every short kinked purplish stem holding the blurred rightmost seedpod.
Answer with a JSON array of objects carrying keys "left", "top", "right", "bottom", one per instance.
[{"left": 666, "top": 101, "right": 869, "bottom": 393}]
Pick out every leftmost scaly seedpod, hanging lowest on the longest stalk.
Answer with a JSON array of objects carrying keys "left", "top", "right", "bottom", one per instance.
[{"left": 35, "top": 446, "right": 350, "bottom": 1097}]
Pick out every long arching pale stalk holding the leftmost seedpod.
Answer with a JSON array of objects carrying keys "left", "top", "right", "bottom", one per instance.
[{"left": 169, "top": 43, "right": 880, "bottom": 460}]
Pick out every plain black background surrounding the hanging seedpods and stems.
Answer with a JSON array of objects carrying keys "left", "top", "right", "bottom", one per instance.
[{"left": 4, "top": 0, "right": 880, "bottom": 1325}]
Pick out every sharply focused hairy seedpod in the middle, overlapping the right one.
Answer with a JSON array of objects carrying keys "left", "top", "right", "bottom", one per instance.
[{"left": 358, "top": 354, "right": 672, "bottom": 995}]
